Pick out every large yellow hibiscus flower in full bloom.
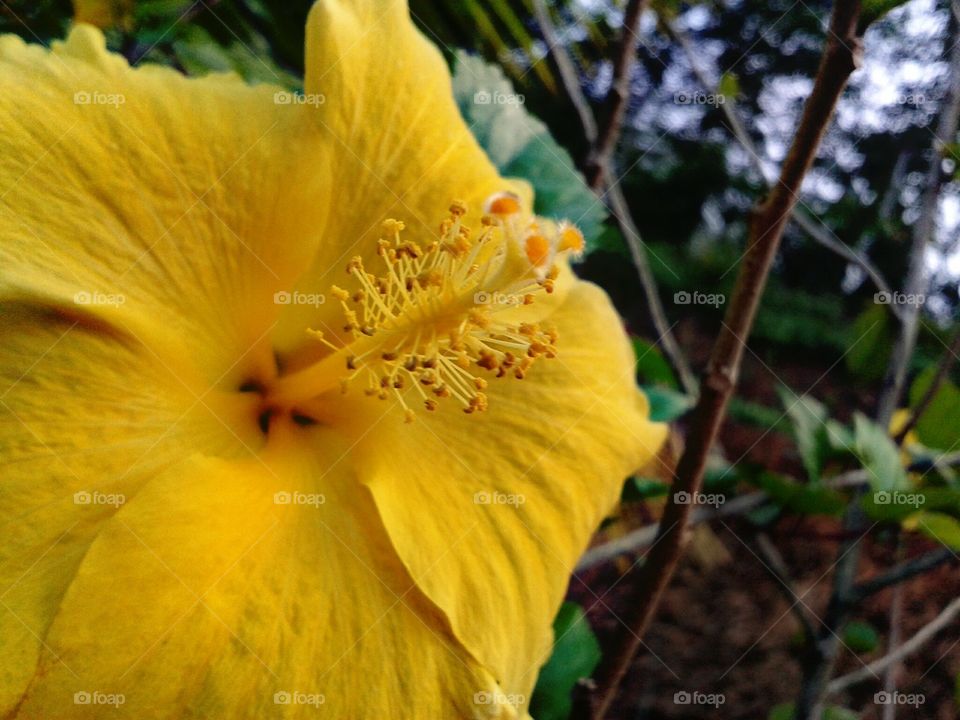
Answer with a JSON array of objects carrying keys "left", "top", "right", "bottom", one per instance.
[{"left": 0, "top": 0, "right": 665, "bottom": 720}]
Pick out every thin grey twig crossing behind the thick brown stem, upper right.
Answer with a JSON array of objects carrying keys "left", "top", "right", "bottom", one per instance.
[{"left": 663, "top": 21, "right": 900, "bottom": 310}]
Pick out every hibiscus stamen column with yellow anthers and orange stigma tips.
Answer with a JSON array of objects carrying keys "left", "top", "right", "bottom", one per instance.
[{"left": 268, "top": 193, "right": 583, "bottom": 422}]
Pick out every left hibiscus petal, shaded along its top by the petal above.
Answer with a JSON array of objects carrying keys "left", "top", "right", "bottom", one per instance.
[{"left": 0, "top": 304, "right": 259, "bottom": 717}]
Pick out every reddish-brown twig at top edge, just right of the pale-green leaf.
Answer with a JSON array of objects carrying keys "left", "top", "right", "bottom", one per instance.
[{"left": 584, "top": 0, "right": 649, "bottom": 191}]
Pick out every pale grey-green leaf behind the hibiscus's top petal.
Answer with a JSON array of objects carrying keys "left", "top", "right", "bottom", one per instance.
[{"left": 453, "top": 51, "right": 607, "bottom": 251}]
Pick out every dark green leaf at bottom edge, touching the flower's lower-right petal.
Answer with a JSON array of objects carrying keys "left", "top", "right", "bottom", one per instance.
[{"left": 530, "top": 602, "right": 600, "bottom": 720}]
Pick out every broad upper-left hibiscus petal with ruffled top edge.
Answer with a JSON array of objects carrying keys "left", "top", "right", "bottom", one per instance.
[{"left": 0, "top": 25, "right": 327, "bottom": 382}]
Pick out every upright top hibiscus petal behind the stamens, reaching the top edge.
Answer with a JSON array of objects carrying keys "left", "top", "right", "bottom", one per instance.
[{"left": 279, "top": 0, "right": 531, "bottom": 364}]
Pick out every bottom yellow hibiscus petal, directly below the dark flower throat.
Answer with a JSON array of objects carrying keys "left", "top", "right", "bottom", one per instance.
[{"left": 9, "top": 433, "right": 516, "bottom": 720}]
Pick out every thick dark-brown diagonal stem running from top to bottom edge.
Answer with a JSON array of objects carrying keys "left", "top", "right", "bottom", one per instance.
[{"left": 580, "top": 0, "right": 860, "bottom": 720}]
